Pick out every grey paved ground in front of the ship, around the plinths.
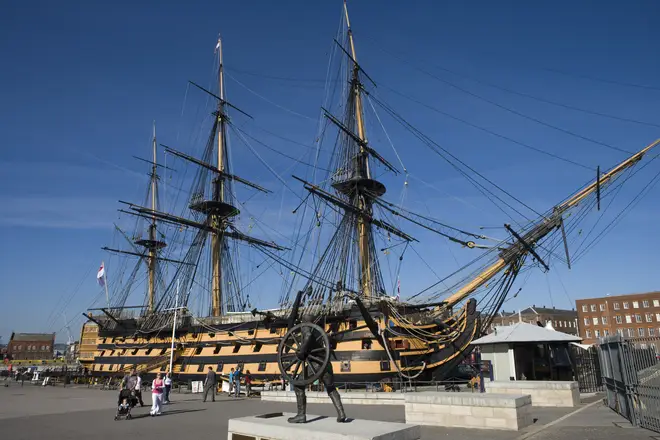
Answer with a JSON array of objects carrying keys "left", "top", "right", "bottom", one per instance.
[{"left": 0, "top": 383, "right": 658, "bottom": 440}]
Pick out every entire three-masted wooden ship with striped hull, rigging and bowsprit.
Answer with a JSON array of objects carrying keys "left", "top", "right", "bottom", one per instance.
[{"left": 81, "top": 4, "right": 659, "bottom": 383}]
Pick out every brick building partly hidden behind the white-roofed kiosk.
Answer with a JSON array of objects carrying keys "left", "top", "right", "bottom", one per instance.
[{"left": 488, "top": 305, "right": 578, "bottom": 335}]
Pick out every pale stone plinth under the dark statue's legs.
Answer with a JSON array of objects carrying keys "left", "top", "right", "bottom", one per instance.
[{"left": 227, "top": 413, "right": 421, "bottom": 440}]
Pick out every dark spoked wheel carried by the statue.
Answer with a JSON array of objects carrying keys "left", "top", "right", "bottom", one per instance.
[{"left": 277, "top": 322, "right": 330, "bottom": 386}]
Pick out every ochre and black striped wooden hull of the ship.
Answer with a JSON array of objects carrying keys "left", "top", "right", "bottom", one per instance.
[{"left": 83, "top": 304, "right": 478, "bottom": 384}]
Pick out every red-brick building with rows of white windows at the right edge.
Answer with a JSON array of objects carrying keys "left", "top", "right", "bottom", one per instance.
[{"left": 575, "top": 291, "right": 660, "bottom": 349}]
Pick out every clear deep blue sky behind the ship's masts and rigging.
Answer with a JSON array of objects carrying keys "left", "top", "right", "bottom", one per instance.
[{"left": 0, "top": 1, "right": 660, "bottom": 341}]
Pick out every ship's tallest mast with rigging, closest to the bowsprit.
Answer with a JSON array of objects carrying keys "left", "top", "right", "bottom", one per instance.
[{"left": 294, "top": 2, "right": 414, "bottom": 301}]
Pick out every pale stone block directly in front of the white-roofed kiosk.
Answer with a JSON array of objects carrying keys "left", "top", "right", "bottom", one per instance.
[{"left": 484, "top": 380, "right": 580, "bottom": 407}]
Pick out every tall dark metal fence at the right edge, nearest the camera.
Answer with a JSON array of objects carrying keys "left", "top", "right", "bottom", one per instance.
[{"left": 600, "top": 335, "right": 660, "bottom": 432}]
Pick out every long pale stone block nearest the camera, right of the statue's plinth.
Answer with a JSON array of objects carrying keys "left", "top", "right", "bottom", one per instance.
[{"left": 405, "top": 392, "right": 532, "bottom": 431}]
